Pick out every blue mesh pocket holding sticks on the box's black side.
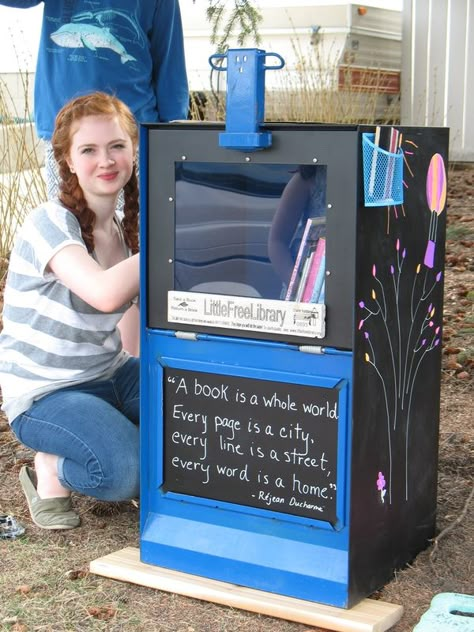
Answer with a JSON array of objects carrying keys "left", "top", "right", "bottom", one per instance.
[{"left": 362, "top": 134, "right": 403, "bottom": 206}]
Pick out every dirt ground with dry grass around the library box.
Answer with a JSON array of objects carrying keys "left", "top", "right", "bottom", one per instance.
[{"left": 0, "top": 165, "right": 474, "bottom": 632}]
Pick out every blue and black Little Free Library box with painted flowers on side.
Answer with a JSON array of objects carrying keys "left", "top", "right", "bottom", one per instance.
[{"left": 136, "top": 123, "right": 448, "bottom": 609}]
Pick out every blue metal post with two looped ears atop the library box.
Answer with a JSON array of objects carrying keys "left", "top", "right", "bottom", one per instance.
[{"left": 209, "top": 48, "right": 285, "bottom": 151}]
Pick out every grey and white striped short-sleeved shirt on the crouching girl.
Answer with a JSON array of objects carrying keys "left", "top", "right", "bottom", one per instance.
[{"left": 0, "top": 201, "right": 129, "bottom": 422}]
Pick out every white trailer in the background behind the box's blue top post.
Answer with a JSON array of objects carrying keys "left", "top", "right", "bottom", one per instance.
[{"left": 181, "top": 0, "right": 401, "bottom": 90}]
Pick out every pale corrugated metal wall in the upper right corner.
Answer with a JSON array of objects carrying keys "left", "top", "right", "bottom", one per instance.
[{"left": 401, "top": 0, "right": 474, "bottom": 162}]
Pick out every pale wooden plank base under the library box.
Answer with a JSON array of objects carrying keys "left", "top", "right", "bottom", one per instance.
[{"left": 90, "top": 547, "right": 403, "bottom": 632}]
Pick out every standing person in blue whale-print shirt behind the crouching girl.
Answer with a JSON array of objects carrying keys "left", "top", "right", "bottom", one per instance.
[{"left": 0, "top": 0, "right": 189, "bottom": 198}]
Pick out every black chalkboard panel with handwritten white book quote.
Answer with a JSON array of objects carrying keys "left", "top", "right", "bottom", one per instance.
[{"left": 163, "top": 368, "right": 339, "bottom": 524}]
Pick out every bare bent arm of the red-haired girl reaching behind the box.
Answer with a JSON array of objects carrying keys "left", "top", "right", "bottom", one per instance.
[{"left": 48, "top": 244, "right": 139, "bottom": 313}]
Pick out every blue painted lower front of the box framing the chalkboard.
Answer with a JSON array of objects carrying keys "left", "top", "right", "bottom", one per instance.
[{"left": 140, "top": 330, "right": 352, "bottom": 607}]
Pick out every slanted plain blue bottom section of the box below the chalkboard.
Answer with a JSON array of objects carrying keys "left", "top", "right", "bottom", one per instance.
[{"left": 141, "top": 514, "right": 348, "bottom": 607}]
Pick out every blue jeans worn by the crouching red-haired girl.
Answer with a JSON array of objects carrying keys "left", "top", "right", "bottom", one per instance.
[{"left": 12, "top": 358, "right": 139, "bottom": 501}]
